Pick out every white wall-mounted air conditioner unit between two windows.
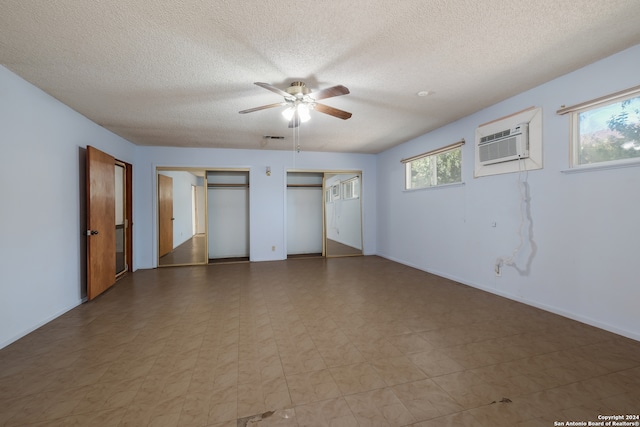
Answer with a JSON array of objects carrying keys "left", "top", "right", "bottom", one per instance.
[{"left": 478, "top": 123, "right": 529, "bottom": 165}]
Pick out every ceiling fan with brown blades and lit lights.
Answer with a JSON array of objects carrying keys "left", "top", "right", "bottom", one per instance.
[{"left": 239, "top": 82, "right": 351, "bottom": 128}]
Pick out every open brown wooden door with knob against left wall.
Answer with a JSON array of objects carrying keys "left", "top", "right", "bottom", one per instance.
[{"left": 86, "top": 146, "right": 116, "bottom": 300}]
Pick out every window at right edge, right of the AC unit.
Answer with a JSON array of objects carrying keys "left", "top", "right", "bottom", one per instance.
[{"left": 558, "top": 87, "right": 640, "bottom": 166}]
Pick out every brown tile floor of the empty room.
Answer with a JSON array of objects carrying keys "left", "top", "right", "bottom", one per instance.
[{"left": 0, "top": 257, "right": 640, "bottom": 427}]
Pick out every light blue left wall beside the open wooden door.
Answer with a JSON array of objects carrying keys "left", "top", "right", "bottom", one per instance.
[{"left": 0, "top": 66, "right": 135, "bottom": 348}]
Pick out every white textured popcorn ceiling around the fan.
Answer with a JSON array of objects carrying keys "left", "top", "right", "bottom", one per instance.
[{"left": 0, "top": 0, "right": 640, "bottom": 153}]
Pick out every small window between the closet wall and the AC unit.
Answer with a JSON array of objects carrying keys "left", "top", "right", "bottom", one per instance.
[{"left": 402, "top": 141, "right": 464, "bottom": 190}]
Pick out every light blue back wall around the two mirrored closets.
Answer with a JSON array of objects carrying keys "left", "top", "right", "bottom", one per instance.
[{"left": 134, "top": 147, "right": 377, "bottom": 268}]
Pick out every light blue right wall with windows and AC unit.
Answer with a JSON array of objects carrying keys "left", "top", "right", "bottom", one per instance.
[{"left": 377, "top": 45, "right": 640, "bottom": 339}]
